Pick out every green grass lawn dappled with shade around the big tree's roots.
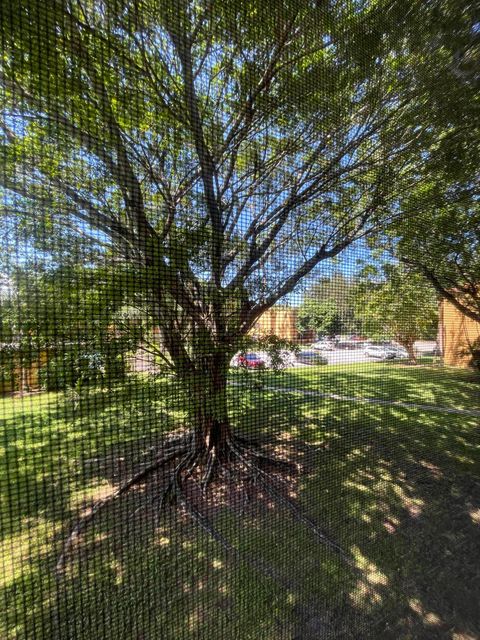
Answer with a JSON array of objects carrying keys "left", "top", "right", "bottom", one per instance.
[{"left": 0, "top": 364, "right": 480, "bottom": 640}]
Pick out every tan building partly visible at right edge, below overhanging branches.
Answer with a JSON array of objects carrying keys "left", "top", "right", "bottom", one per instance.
[{"left": 438, "top": 300, "right": 480, "bottom": 368}]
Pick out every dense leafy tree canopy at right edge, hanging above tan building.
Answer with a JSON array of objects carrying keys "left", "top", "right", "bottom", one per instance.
[{"left": 381, "top": 1, "right": 480, "bottom": 322}]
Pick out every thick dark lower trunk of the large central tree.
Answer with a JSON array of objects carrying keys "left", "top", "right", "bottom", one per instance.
[{"left": 183, "top": 353, "right": 230, "bottom": 461}]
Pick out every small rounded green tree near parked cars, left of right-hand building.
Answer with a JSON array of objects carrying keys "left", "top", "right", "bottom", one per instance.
[{"left": 357, "top": 265, "right": 438, "bottom": 362}]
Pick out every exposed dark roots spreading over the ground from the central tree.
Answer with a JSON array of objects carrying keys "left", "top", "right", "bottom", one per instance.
[{"left": 56, "top": 434, "right": 356, "bottom": 585}]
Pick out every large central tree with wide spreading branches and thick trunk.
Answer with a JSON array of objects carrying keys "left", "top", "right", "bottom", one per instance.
[{"left": 0, "top": 0, "right": 452, "bottom": 496}]
